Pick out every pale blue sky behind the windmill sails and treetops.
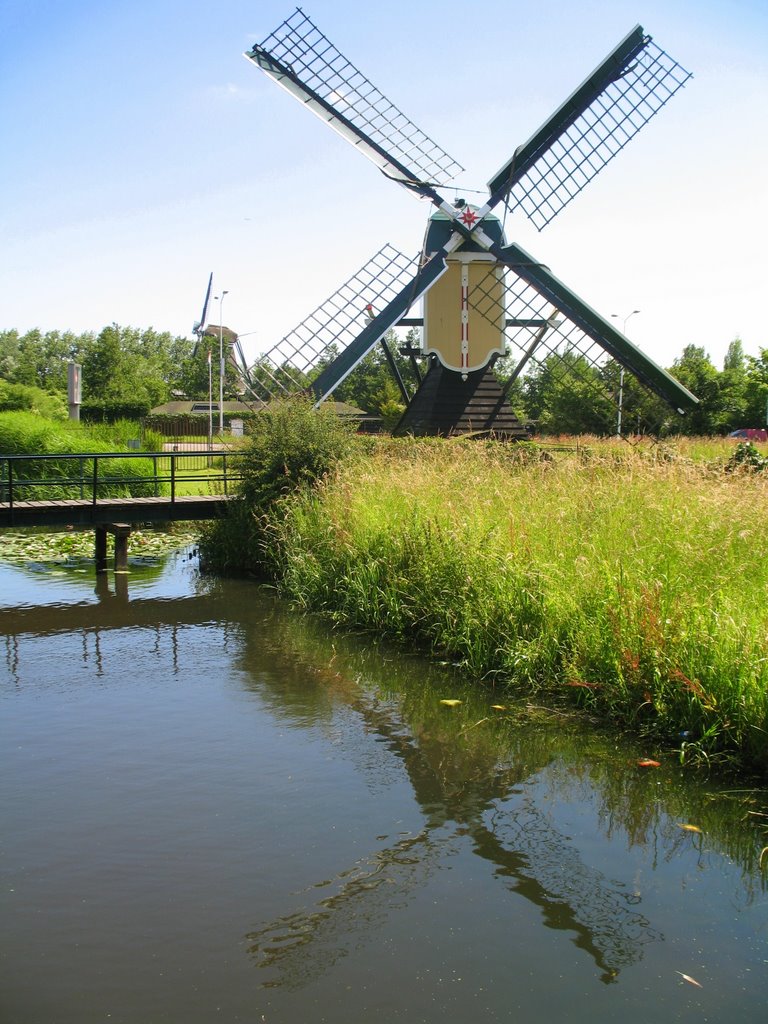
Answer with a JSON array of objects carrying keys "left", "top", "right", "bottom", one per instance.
[{"left": 0, "top": 0, "right": 768, "bottom": 366}]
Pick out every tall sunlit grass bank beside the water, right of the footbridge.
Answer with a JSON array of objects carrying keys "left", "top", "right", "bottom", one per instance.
[{"left": 249, "top": 442, "right": 768, "bottom": 770}]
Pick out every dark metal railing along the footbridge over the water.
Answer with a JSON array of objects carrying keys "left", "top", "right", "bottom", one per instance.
[{"left": 0, "top": 451, "right": 242, "bottom": 508}]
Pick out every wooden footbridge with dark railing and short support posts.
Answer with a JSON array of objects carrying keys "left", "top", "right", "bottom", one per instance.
[{"left": 0, "top": 451, "right": 241, "bottom": 571}]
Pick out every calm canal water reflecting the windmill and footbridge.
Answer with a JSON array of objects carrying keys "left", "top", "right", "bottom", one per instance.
[{"left": 0, "top": 552, "right": 768, "bottom": 1024}]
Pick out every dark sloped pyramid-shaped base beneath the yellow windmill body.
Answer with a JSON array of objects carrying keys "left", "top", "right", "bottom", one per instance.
[{"left": 393, "top": 359, "right": 528, "bottom": 440}]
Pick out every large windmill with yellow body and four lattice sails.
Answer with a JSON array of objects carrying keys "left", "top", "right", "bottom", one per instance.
[{"left": 245, "top": 8, "right": 697, "bottom": 436}]
